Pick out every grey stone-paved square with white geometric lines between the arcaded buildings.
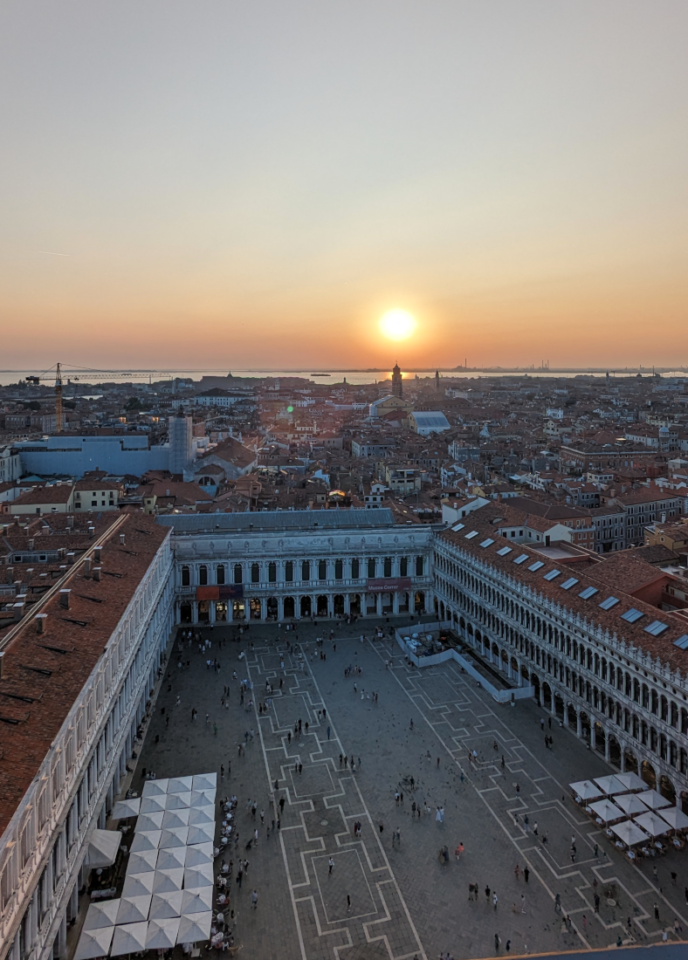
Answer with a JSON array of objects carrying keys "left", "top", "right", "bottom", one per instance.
[{"left": 134, "top": 624, "right": 688, "bottom": 960}]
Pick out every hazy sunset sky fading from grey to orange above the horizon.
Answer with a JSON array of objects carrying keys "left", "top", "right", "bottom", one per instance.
[{"left": 0, "top": 0, "right": 688, "bottom": 371}]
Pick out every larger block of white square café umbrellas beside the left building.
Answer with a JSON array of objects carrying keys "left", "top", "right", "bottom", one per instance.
[{"left": 74, "top": 773, "right": 217, "bottom": 960}]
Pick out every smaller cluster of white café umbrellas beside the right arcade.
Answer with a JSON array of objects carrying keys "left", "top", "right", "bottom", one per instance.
[{"left": 569, "top": 773, "right": 688, "bottom": 861}]
